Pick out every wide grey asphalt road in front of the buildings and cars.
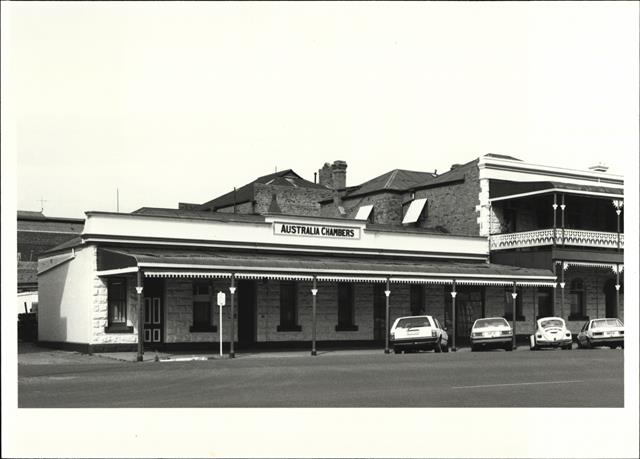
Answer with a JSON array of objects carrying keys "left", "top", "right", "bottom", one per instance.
[{"left": 18, "top": 349, "right": 624, "bottom": 408}]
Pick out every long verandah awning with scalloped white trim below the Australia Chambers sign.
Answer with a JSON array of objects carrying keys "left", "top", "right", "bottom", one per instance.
[{"left": 98, "top": 247, "right": 556, "bottom": 287}]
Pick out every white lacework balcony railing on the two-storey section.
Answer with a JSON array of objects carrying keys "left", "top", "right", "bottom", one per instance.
[{"left": 489, "top": 229, "right": 624, "bottom": 250}]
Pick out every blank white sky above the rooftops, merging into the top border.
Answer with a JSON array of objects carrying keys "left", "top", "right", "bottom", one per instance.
[{"left": 2, "top": 2, "right": 638, "bottom": 217}]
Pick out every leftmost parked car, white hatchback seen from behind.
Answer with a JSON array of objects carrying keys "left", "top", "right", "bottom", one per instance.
[{"left": 391, "top": 316, "right": 449, "bottom": 354}]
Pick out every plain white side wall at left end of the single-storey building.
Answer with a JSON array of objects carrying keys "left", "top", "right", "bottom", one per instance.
[{"left": 38, "top": 246, "right": 96, "bottom": 344}]
